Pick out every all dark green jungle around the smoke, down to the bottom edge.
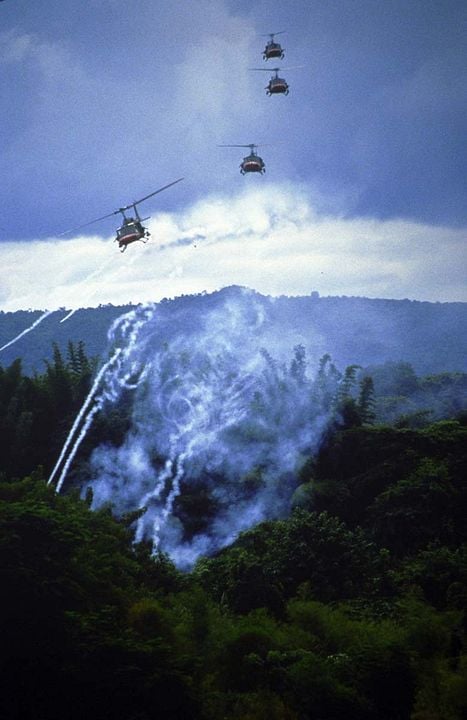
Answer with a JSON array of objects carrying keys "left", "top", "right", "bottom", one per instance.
[{"left": 0, "top": 343, "right": 467, "bottom": 720}]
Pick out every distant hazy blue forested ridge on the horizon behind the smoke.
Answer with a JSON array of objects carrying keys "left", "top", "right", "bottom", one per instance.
[{"left": 0, "top": 287, "right": 467, "bottom": 374}]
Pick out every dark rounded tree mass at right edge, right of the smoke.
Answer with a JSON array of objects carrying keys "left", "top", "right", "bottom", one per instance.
[{"left": 312, "top": 421, "right": 467, "bottom": 554}]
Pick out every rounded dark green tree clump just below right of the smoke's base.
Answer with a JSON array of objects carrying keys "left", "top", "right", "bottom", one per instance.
[{"left": 195, "top": 509, "right": 390, "bottom": 615}]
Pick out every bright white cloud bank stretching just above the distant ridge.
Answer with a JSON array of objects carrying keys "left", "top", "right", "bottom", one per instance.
[{"left": 0, "top": 184, "right": 467, "bottom": 310}]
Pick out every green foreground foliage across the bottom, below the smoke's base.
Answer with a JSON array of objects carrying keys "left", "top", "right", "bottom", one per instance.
[{"left": 0, "top": 458, "right": 467, "bottom": 720}]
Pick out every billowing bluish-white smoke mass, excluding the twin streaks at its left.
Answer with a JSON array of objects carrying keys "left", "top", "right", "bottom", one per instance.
[{"left": 83, "top": 291, "right": 332, "bottom": 567}]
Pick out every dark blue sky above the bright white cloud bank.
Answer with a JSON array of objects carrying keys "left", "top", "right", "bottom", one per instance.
[{"left": 0, "top": 0, "right": 467, "bottom": 239}]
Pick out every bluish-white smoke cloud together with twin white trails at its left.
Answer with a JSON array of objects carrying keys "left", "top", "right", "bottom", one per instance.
[{"left": 23, "top": 288, "right": 462, "bottom": 567}]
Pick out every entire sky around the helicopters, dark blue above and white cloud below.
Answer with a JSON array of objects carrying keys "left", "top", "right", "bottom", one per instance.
[{"left": 0, "top": 0, "right": 467, "bottom": 310}]
